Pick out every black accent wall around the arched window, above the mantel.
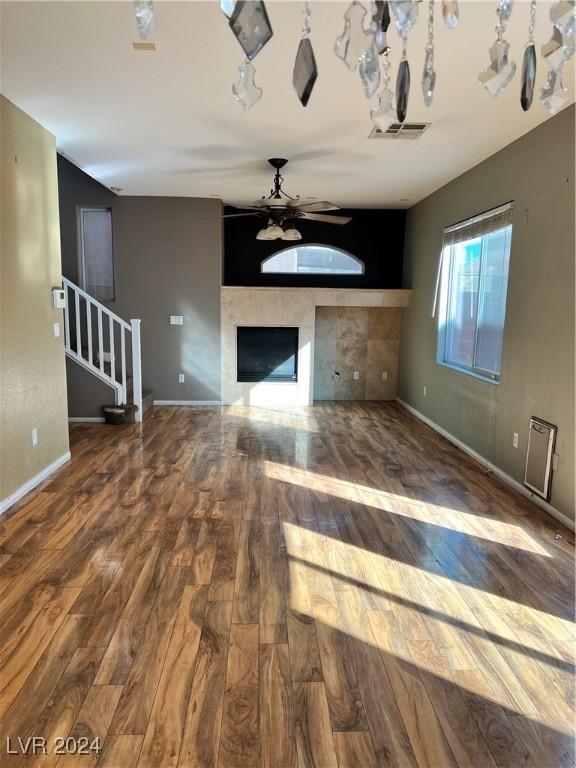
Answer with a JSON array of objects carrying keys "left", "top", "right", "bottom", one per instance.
[{"left": 224, "top": 209, "right": 406, "bottom": 288}]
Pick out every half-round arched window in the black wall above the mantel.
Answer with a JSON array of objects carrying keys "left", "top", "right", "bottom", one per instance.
[{"left": 262, "top": 245, "right": 364, "bottom": 275}]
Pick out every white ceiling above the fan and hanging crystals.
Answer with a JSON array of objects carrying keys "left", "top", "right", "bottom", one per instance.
[{"left": 1, "top": 0, "right": 574, "bottom": 207}]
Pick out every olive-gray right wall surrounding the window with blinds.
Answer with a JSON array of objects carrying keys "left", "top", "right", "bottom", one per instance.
[{"left": 399, "top": 106, "right": 575, "bottom": 518}]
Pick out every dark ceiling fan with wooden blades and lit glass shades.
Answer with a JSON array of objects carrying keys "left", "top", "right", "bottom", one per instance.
[{"left": 222, "top": 157, "right": 351, "bottom": 240}]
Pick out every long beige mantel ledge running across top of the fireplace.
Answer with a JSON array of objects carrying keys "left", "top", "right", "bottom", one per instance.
[{"left": 221, "top": 285, "right": 412, "bottom": 307}]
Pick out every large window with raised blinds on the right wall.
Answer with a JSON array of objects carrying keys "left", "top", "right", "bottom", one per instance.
[{"left": 438, "top": 203, "right": 512, "bottom": 382}]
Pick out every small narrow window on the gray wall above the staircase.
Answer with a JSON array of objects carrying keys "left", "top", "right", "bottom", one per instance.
[{"left": 78, "top": 208, "right": 114, "bottom": 301}]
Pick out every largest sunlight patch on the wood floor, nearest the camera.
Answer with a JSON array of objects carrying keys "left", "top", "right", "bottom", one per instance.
[{"left": 283, "top": 523, "right": 573, "bottom": 729}]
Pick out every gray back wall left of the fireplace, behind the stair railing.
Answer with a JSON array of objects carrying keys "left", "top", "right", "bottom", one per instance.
[{"left": 59, "top": 159, "right": 222, "bottom": 416}]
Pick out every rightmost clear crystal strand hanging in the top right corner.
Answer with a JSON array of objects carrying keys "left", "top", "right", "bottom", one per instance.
[{"left": 540, "top": 0, "right": 576, "bottom": 112}]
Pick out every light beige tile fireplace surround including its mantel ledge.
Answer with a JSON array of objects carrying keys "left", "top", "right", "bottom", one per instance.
[{"left": 221, "top": 286, "right": 411, "bottom": 407}]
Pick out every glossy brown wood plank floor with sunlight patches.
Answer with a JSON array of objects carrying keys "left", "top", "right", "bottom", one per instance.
[{"left": 0, "top": 403, "right": 575, "bottom": 768}]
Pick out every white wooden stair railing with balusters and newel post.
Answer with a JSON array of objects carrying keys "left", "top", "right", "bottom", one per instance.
[{"left": 62, "top": 277, "right": 142, "bottom": 421}]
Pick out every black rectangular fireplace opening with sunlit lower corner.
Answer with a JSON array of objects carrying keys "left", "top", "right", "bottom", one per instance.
[{"left": 236, "top": 327, "right": 298, "bottom": 381}]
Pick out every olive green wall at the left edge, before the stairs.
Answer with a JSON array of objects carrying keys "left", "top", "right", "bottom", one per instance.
[{"left": 0, "top": 96, "right": 68, "bottom": 509}]
